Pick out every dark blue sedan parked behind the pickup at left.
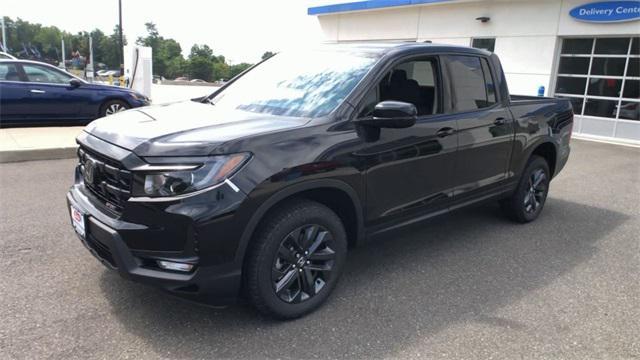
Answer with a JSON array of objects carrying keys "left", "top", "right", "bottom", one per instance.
[{"left": 0, "top": 59, "right": 150, "bottom": 125}]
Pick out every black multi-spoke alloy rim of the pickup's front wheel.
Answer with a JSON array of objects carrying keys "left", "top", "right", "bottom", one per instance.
[{"left": 271, "top": 225, "right": 336, "bottom": 304}]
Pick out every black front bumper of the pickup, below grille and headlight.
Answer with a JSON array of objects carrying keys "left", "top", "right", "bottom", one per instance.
[{"left": 67, "top": 182, "right": 241, "bottom": 304}]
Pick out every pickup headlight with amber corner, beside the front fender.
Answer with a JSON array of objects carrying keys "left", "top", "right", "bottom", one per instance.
[{"left": 141, "top": 153, "right": 250, "bottom": 197}]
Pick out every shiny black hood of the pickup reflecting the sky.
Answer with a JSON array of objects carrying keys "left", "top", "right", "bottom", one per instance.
[{"left": 84, "top": 101, "right": 309, "bottom": 156}]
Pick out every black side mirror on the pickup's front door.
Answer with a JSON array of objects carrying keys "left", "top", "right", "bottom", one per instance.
[{"left": 356, "top": 100, "right": 418, "bottom": 129}]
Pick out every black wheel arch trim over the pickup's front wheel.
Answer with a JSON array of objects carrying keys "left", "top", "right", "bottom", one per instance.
[{"left": 236, "top": 179, "right": 364, "bottom": 266}]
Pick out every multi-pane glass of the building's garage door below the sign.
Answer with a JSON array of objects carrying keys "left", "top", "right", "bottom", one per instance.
[{"left": 555, "top": 37, "right": 640, "bottom": 121}]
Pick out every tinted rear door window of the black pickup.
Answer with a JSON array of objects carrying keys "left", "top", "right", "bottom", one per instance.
[{"left": 447, "top": 55, "right": 496, "bottom": 112}]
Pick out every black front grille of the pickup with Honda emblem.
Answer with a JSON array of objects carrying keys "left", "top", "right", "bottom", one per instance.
[{"left": 78, "top": 147, "right": 133, "bottom": 213}]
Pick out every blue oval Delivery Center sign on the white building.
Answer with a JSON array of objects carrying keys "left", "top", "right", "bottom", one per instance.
[{"left": 569, "top": 1, "right": 640, "bottom": 23}]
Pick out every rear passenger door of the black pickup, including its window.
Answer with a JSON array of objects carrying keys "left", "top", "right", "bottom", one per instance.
[{"left": 444, "top": 55, "right": 514, "bottom": 202}]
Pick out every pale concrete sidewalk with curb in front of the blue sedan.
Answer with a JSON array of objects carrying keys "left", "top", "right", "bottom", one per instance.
[{"left": 0, "top": 126, "right": 84, "bottom": 163}]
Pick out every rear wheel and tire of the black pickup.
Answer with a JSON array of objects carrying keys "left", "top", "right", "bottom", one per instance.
[{"left": 500, "top": 155, "right": 551, "bottom": 223}]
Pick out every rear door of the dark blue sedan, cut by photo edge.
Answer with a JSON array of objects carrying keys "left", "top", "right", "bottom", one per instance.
[{"left": 0, "top": 61, "right": 29, "bottom": 122}]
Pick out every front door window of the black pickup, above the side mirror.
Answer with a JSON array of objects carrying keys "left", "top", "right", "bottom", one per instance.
[{"left": 359, "top": 58, "right": 440, "bottom": 117}]
